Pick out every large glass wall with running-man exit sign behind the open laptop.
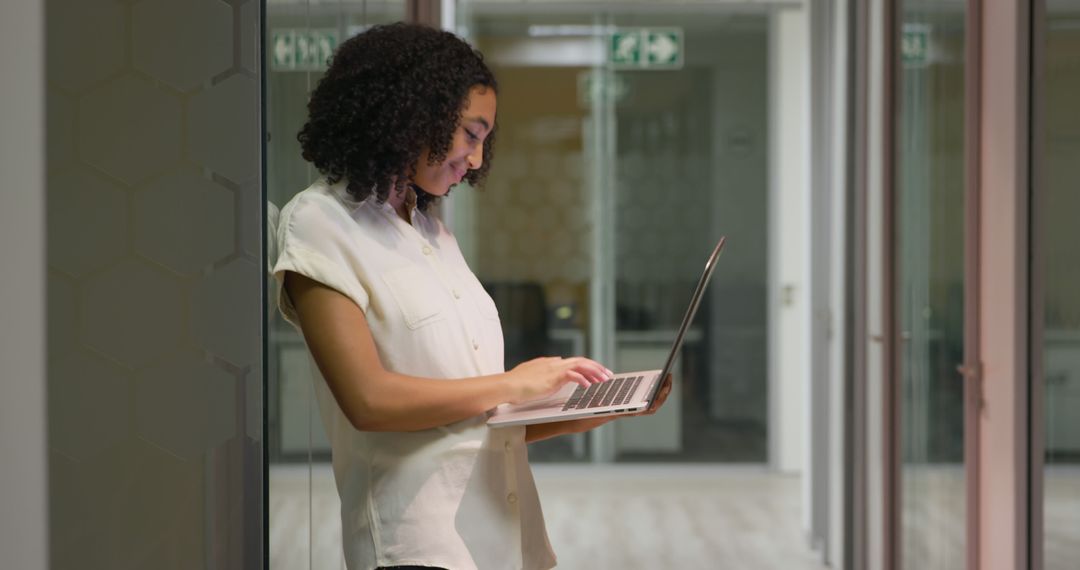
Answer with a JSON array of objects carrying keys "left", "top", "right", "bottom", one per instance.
[{"left": 460, "top": 3, "right": 769, "bottom": 462}]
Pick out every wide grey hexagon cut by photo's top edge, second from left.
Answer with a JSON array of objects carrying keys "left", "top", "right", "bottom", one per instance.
[{"left": 132, "top": 0, "right": 232, "bottom": 91}]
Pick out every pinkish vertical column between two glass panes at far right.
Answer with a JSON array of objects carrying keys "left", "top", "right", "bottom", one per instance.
[{"left": 974, "top": 0, "right": 1031, "bottom": 570}]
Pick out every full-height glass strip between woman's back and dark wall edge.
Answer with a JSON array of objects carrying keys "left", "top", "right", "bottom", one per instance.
[{"left": 264, "top": 0, "right": 405, "bottom": 570}]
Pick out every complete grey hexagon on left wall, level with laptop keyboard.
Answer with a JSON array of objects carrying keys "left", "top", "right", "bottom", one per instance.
[{"left": 135, "top": 353, "right": 237, "bottom": 459}]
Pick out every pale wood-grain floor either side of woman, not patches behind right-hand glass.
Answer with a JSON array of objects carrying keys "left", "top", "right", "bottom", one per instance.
[{"left": 270, "top": 465, "right": 825, "bottom": 570}]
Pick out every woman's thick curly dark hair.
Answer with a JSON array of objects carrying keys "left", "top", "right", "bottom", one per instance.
[{"left": 297, "top": 23, "right": 498, "bottom": 211}]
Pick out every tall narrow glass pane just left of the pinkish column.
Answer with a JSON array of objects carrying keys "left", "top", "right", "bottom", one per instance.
[{"left": 895, "top": 1, "right": 966, "bottom": 570}]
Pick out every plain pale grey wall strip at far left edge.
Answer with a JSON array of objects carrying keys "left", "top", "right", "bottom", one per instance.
[{"left": 0, "top": 0, "right": 49, "bottom": 570}]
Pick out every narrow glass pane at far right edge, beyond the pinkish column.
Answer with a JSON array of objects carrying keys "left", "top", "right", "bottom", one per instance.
[{"left": 1034, "top": 5, "right": 1080, "bottom": 570}]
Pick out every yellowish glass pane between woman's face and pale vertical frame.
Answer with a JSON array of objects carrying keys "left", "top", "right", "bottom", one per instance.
[{"left": 464, "top": 11, "right": 598, "bottom": 462}]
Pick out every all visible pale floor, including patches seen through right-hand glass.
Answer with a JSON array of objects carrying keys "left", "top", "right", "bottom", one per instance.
[{"left": 270, "top": 464, "right": 1080, "bottom": 570}]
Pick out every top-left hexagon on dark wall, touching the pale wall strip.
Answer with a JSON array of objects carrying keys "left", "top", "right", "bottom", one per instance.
[{"left": 45, "top": 0, "right": 127, "bottom": 92}]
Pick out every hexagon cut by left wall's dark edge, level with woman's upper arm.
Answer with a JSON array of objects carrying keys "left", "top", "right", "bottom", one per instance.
[{"left": 191, "top": 259, "right": 262, "bottom": 366}]
